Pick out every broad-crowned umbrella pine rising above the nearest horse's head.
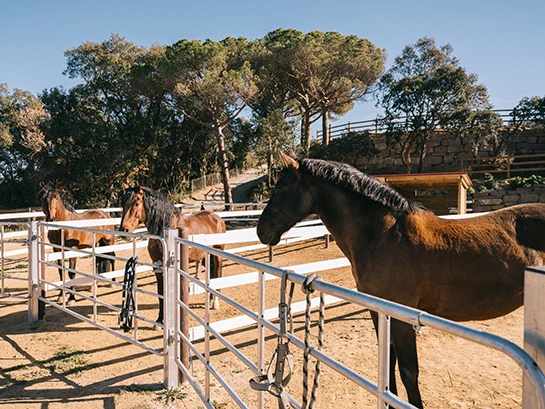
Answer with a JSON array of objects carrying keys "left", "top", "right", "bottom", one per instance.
[{"left": 256, "top": 29, "right": 384, "bottom": 153}]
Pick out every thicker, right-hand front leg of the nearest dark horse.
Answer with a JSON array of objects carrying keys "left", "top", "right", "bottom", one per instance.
[{"left": 391, "top": 319, "right": 424, "bottom": 408}]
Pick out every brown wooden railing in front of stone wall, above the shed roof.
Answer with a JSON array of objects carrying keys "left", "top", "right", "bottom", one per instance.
[{"left": 460, "top": 153, "right": 545, "bottom": 178}]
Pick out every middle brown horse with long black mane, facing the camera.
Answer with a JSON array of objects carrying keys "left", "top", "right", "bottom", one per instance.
[{"left": 119, "top": 184, "right": 226, "bottom": 323}]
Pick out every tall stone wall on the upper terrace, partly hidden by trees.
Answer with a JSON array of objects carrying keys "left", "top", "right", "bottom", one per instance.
[{"left": 353, "top": 130, "right": 545, "bottom": 174}]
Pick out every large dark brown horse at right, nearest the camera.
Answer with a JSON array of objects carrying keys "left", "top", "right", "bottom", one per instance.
[{"left": 257, "top": 155, "right": 545, "bottom": 408}]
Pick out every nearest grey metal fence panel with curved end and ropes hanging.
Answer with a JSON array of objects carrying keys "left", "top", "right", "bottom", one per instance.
[{"left": 173, "top": 233, "right": 545, "bottom": 409}]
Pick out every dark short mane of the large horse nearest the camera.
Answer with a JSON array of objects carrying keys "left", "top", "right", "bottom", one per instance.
[{"left": 298, "top": 159, "right": 424, "bottom": 213}]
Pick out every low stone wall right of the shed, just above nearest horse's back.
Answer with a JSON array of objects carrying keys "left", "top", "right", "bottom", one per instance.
[{"left": 468, "top": 185, "right": 545, "bottom": 213}]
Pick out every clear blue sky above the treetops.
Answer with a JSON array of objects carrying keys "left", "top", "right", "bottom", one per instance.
[{"left": 0, "top": 0, "right": 545, "bottom": 127}]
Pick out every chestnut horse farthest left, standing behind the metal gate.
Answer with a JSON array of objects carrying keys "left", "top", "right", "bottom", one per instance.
[{"left": 37, "top": 182, "right": 115, "bottom": 303}]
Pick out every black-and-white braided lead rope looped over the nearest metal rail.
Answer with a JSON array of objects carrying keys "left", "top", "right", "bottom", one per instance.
[{"left": 301, "top": 274, "right": 325, "bottom": 409}]
